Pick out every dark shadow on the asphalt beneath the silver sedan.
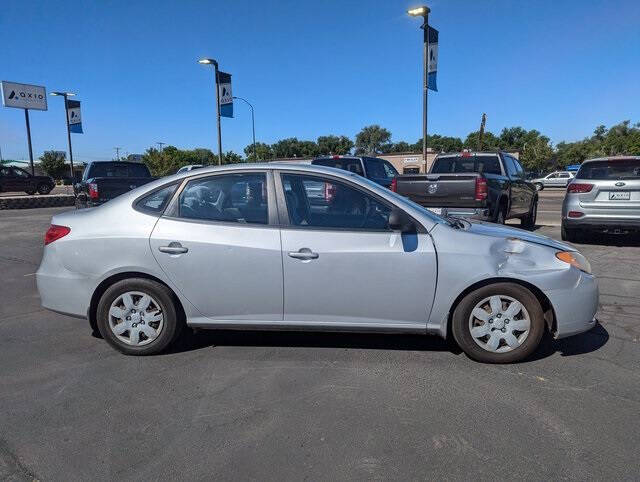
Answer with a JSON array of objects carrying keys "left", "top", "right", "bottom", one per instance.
[{"left": 166, "top": 323, "right": 609, "bottom": 361}]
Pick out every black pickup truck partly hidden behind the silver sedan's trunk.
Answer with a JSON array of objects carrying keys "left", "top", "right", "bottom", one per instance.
[{"left": 73, "top": 161, "right": 155, "bottom": 209}]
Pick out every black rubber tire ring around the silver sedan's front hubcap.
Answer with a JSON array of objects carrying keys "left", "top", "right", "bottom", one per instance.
[{"left": 452, "top": 283, "right": 545, "bottom": 363}]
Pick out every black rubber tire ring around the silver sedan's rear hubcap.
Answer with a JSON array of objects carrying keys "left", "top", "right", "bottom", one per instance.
[{"left": 96, "top": 278, "right": 184, "bottom": 355}]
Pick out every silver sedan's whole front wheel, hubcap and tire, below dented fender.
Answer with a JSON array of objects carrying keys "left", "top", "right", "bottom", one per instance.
[{"left": 452, "top": 283, "right": 545, "bottom": 363}]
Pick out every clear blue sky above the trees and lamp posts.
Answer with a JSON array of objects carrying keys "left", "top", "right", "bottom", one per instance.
[{"left": 0, "top": 0, "right": 640, "bottom": 160}]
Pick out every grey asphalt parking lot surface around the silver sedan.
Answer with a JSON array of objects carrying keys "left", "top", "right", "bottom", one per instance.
[{"left": 0, "top": 190, "right": 640, "bottom": 480}]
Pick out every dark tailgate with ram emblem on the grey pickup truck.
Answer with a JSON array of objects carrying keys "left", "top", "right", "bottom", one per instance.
[{"left": 396, "top": 173, "right": 483, "bottom": 207}]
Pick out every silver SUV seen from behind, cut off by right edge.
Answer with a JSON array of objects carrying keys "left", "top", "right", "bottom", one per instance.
[{"left": 562, "top": 156, "right": 640, "bottom": 242}]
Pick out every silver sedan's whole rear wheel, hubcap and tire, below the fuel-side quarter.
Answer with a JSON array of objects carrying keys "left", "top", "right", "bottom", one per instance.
[{"left": 97, "top": 278, "right": 183, "bottom": 355}]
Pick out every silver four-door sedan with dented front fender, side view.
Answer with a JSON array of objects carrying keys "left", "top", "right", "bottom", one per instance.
[{"left": 36, "top": 163, "right": 598, "bottom": 363}]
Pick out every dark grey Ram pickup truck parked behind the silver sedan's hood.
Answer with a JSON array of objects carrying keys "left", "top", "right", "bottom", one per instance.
[{"left": 392, "top": 152, "right": 538, "bottom": 229}]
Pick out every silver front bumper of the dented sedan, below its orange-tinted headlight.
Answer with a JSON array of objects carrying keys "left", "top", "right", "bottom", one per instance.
[{"left": 544, "top": 268, "right": 599, "bottom": 339}]
